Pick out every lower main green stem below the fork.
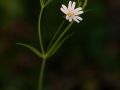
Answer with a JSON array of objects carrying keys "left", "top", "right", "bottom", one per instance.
[{"left": 38, "top": 58, "right": 46, "bottom": 90}]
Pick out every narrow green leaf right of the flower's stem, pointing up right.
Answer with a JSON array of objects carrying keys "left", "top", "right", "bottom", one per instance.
[{"left": 48, "top": 33, "right": 73, "bottom": 57}]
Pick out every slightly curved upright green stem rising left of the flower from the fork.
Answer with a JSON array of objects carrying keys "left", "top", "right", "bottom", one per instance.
[{"left": 38, "top": 8, "right": 45, "bottom": 55}]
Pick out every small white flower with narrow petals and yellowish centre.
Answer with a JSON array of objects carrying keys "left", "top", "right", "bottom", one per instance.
[{"left": 60, "top": 1, "right": 83, "bottom": 23}]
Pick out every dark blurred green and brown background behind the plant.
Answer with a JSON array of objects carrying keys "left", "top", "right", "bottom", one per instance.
[{"left": 0, "top": 0, "right": 120, "bottom": 90}]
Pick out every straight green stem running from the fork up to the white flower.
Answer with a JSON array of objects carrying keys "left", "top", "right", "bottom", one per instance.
[{"left": 47, "top": 22, "right": 74, "bottom": 56}]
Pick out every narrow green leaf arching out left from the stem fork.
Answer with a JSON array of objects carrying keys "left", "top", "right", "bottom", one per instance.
[{"left": 16, "top": 43, "right": 43, "bottom": 58}]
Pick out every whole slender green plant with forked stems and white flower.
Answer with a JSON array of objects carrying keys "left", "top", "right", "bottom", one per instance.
[{"left": 16, "top": 0, "right": 87, "bottom": 90}]
